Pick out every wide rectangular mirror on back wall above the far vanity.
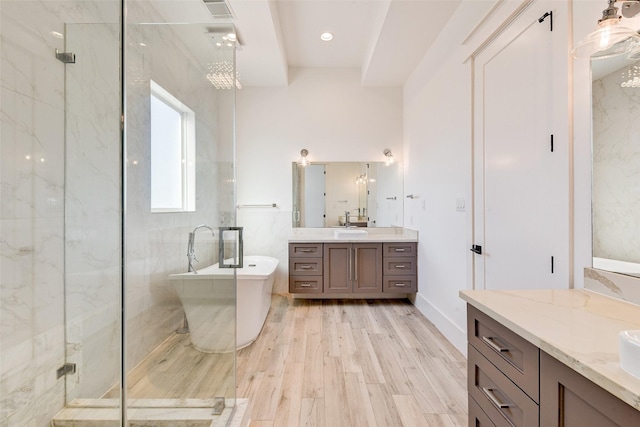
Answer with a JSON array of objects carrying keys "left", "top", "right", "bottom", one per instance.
[{"left": 292, "top": 162, "right": 403, "bottom": 228}]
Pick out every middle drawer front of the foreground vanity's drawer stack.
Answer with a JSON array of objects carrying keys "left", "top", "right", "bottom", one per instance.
[{"left": 467, "top": 345, "right": 540, "bottom": 427}]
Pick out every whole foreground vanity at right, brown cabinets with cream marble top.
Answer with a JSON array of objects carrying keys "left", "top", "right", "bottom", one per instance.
[{"left": 460, "top": 290, "right": 640, "bottom": 427}]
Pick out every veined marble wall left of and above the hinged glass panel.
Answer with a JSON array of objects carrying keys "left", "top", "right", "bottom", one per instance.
[{"left": 0, "top": 0, "right": 119, "bottom": 427}]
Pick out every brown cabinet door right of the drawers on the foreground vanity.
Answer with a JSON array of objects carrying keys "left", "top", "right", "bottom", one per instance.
[{"left": 540, "top": 352, "right": 640, "bottom": 427}]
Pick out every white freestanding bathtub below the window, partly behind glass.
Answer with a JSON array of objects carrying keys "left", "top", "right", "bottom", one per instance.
[{"left": 169, "top": 256, "right": 278, "bottom": 353}]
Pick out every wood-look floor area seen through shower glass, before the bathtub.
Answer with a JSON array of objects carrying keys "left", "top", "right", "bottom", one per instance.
[{"left": 104, "top": 334, "right": 235, "bottom": 399}]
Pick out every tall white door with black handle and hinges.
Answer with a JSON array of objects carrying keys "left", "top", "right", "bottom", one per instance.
[{"left": 474, "top": 4, "right": 569, "bottom": 289}]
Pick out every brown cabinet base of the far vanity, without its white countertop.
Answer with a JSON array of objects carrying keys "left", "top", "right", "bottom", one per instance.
[{"left": 289, "top": 242, "right": 418, "bottom": 297}]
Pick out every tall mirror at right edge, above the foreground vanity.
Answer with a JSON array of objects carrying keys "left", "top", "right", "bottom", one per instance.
[{"left": 591, "top": 57, "right": 640, "bottom": 277}]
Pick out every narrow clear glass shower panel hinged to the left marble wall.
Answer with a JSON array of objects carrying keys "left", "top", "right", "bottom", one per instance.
[{"left": 64, "top": 18, "right": 122, "bottom": 407}]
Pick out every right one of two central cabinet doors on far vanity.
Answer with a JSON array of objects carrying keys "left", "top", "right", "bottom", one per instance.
[{"left": 353, "top": 243, "right": 382, "bottom": 292}]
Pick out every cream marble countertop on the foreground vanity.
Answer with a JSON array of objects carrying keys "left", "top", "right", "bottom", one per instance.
[{"left": 460, "top": 289, "right": 640, "bottom": 410}]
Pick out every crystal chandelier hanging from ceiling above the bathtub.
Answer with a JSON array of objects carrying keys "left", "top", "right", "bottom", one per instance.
[{"left": 207, "top": 32, "right": 242, "bottom": 89}]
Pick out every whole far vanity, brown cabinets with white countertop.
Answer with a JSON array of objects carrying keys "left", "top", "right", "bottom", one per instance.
[{"left": 289, "top": 228, "right": 418, "bottom": 298}]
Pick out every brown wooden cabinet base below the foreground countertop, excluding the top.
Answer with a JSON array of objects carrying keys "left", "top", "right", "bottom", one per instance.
[{"left": 467, "top": 305, "right": 640, "bottom": 427}]
